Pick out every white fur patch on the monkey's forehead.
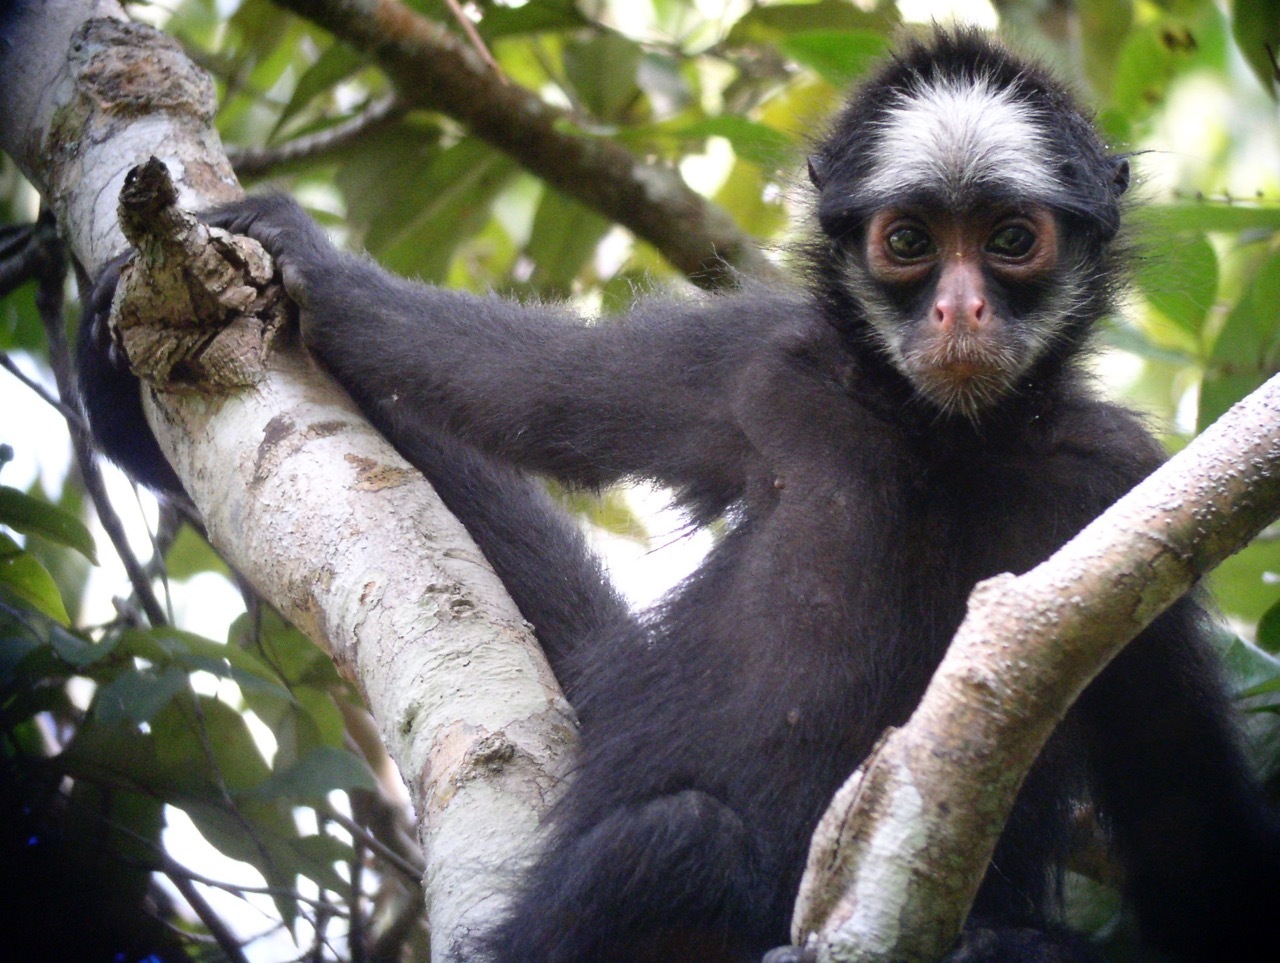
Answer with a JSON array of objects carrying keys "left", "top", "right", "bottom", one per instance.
[{"left": 860, "top": 78, "right": 1062, "bottom": 200}]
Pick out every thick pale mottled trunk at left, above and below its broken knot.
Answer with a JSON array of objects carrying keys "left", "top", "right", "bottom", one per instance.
[{"left": 0, "top": 0, "right": 572, "bottom": 960}]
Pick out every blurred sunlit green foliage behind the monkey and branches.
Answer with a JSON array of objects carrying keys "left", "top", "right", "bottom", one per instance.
[{"left": 0, "top": 0, "right": 1280, "bottom": 960}]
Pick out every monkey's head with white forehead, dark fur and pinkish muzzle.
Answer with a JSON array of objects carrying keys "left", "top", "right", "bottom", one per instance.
[{"left": 809, "top": 35, "right": 1128, "bottom": 421}]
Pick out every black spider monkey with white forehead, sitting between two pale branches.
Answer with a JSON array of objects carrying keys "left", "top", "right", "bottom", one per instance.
[{"left": 82, "top": 31, "right": 1280, "bottom": 963}]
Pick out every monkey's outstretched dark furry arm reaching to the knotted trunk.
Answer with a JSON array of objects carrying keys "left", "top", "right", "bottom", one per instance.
[{"left": 210, "top": 190, "right": 778, "bottom": 512}]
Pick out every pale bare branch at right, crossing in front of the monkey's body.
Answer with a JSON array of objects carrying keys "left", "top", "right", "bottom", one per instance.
[{"left": 795, "top": 376, "right": 1280, "bottom": 962}]
